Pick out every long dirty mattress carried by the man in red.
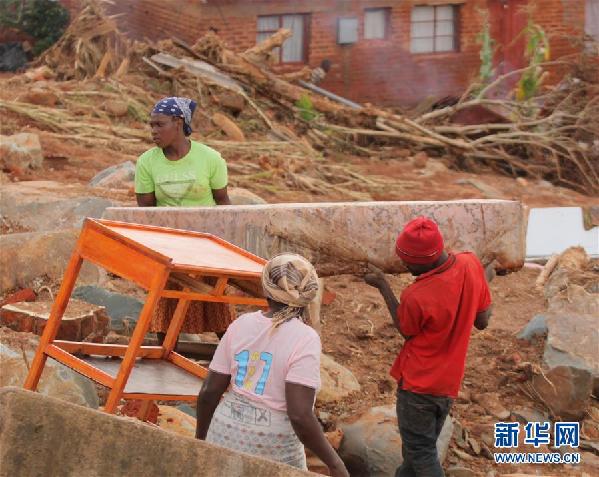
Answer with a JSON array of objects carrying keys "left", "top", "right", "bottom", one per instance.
[{"left": 104, "top": 200, "right": 526, "bottom": 276}]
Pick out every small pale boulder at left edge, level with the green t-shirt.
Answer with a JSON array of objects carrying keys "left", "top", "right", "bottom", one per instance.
[{"left": 0, "top": 133, "right": 44, "bottom": 171}]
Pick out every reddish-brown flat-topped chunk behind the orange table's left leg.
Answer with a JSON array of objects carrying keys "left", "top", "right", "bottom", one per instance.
[{"left": 0, "top": 300, "right": 110, "bottom": 342}]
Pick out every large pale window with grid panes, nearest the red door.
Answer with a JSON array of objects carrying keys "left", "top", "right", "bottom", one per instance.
[{"left": 410, "top": 5, "right": 459, "bottom": 53}]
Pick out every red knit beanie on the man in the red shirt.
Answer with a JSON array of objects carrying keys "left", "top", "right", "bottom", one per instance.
[{"left": 395, "top": 217, "right": 444, "bottom": 265}]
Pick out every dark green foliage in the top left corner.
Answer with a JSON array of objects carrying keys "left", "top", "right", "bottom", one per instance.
[{"left": 0, "top": 0, "right": 69, "bottom": 55}]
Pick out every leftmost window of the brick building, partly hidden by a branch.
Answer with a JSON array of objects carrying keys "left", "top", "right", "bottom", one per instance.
[{"left": 256, "top": 15, "right": 308, "bottom": 63}]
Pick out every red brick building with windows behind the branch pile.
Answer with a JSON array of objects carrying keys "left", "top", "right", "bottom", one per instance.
[{"left": 69, "top": 0, "right": 599, "bottom": 105}]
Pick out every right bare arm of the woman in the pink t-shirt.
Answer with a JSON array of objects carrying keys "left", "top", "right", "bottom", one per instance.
[{"left": 288, "top": 382, "right": 349, "bottom": 477}]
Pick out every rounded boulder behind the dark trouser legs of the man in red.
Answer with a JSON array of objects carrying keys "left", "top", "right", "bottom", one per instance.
[{"left": 339, "top": 405, "right": 453, "bottom": 477}]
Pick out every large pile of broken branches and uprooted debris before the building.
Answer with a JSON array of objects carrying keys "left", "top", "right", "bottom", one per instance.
[{"left": 0, "top": 1, "right": 599, "bottom": 197}]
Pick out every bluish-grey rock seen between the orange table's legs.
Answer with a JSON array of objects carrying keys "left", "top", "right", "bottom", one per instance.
[{"left": 73, "top": 285, "right": 144, "bottom": 332}]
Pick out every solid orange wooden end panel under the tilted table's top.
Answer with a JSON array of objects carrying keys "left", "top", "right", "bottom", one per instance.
[{"left": 80, "top": 220, "right": 169, "bottom": 290}]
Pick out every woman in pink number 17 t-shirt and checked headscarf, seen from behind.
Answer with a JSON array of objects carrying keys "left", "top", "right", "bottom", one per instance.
[{"left": 196, "top": 254, "right": 349, "bottom": 477}]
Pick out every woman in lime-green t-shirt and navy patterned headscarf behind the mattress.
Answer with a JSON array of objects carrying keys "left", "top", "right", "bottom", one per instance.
[{"left": 135, "top": 97, "right": 235, "bottom": 344}]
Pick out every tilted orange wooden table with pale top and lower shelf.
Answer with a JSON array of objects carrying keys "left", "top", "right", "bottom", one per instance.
[{"left": 24, "top": 219, "right": 267, "bottom": 413}]
